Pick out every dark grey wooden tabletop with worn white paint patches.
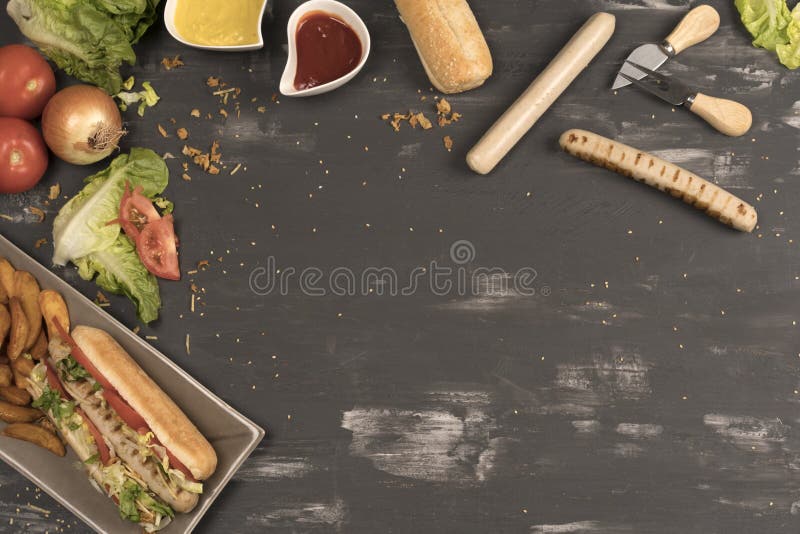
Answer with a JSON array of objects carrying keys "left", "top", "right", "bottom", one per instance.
[{"left": 0, "top": 0, "right": 800, "bottom": 533}]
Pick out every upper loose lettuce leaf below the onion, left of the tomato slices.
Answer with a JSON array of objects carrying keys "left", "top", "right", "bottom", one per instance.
[{"left": 53, "top": 148, "right": 169, "bottom": 265}]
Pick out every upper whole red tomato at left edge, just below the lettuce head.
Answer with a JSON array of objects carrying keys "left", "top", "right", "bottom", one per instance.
[{"left": 0, "top": 45, "right": 56, "bottom": 119}]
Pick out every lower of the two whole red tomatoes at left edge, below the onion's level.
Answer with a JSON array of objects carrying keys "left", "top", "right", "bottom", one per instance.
[{"left": 0, "top": 118, "right": 47, "bottom": 193}]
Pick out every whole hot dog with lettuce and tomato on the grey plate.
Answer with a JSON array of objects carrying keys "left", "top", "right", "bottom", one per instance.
[{"left": 28, "top": 323, "right": 217, "bottom": 532}]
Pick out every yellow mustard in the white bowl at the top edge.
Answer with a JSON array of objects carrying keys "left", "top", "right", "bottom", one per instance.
[{"left": 175, "top": 0, "right": 265, "bottom": 46}]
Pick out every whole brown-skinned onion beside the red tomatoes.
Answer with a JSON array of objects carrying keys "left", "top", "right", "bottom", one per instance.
[{"left": 42, "top": 85, "right": 126, "bottom": 165}]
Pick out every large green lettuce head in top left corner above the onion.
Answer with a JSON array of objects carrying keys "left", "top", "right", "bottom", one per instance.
[{"left": 6, "top": 0, "right": 158, "bottom": 95}]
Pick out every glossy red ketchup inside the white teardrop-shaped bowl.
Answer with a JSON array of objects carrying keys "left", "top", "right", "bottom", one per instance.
[{"left": 294, "top": 11, "right": 362, "bottom": 91}]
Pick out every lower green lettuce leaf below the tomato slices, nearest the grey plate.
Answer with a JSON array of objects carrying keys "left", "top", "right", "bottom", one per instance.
[{"left": 74, "top": 234, "right": 161, "bottom": 323}]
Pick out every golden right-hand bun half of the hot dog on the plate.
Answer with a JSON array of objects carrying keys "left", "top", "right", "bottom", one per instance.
[{"left": 72, "top": 326, "right": 217, "bottom": 480}]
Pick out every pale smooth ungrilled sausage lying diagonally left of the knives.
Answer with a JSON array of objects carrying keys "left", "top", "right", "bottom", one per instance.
[{"left": 467, "top": 13, "right": 616, "bottom": 174}]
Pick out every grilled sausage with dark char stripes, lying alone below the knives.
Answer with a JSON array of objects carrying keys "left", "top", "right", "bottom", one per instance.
[{"left": 559, "top": 130, "right": 758, "bottom": 232}]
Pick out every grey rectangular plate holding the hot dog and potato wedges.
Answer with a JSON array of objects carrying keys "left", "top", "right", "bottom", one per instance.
[{"left": 0, "top": 235, "right": 264, "bottom": 534}]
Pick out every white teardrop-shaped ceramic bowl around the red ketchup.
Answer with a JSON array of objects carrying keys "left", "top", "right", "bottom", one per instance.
[{"left": 280, "top": 0, "right": 370, "bottom": 96}]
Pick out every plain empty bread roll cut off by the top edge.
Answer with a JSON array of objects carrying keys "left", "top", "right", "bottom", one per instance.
[{"left": 395, "top": 0, "right": 492, "bottom": 94}]
